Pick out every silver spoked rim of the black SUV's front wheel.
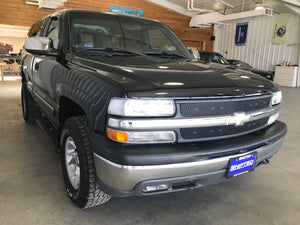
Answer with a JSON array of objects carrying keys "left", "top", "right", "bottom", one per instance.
[{"left": 65, "top": 137, "right": 80, "bottom": 190}]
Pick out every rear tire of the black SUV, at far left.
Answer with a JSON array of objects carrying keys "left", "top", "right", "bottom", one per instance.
[{"left": 21, "top": 83, "right": 36, "bottom": 124}]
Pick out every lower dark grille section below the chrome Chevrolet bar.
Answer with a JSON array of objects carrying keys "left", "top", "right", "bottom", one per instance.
[{"left": 180, "top": 117, "right": 269, "bottom": 140}]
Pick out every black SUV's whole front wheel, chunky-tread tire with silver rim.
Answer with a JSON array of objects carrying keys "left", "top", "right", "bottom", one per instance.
[{"left": 61, "top": 116, "right": 111, "bottom": 208}]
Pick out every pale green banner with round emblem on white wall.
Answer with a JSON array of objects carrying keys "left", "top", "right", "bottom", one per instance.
[{"left": 272, "top": 16, "right": 290, "bottom": 44}]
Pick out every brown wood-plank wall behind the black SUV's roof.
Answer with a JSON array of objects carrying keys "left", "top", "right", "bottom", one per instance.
[{"left": 0, "top": 0, "right": 214, "bottom": 50}]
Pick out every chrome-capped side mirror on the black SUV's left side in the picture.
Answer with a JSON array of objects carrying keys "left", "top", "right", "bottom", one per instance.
[{"left": 24, "top": 37, "right": 57, "bottom": 56}]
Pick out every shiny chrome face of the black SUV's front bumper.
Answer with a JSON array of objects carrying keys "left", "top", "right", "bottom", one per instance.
[{"left": 94, "top": 136, "right": 284, "bottom": 192}]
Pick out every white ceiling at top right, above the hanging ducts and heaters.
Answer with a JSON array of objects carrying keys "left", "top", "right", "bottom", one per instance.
[{"left": 157, "top": 0, "right": 292, "bottom": 14}]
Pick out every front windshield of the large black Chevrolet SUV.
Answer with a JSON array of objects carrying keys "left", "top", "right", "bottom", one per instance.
[{"left": 70, "top": 12, "right": 190, "bottom": 58}]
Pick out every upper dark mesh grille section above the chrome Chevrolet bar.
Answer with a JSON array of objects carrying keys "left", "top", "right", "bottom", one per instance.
[{"left": 179, "top": 95, "right": 271, "bottom": 117}]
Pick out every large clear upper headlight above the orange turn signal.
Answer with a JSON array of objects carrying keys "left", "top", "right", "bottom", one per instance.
[{"left": 108, "top": 98, "right": 175, "bottom": 117}]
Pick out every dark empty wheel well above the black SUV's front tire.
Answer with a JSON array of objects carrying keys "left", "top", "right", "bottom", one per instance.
[{"left": 59, "top": 97, "right": 86, "bottom": 125}]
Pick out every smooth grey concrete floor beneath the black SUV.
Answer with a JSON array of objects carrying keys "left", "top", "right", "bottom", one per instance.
[{"left": 0, "top": 81, "right": 300, "bottom": 225}]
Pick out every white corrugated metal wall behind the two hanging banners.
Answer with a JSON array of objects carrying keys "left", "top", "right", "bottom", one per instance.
[{"left": 215, "top": 14, "right": 300, "bottom": 71}]
